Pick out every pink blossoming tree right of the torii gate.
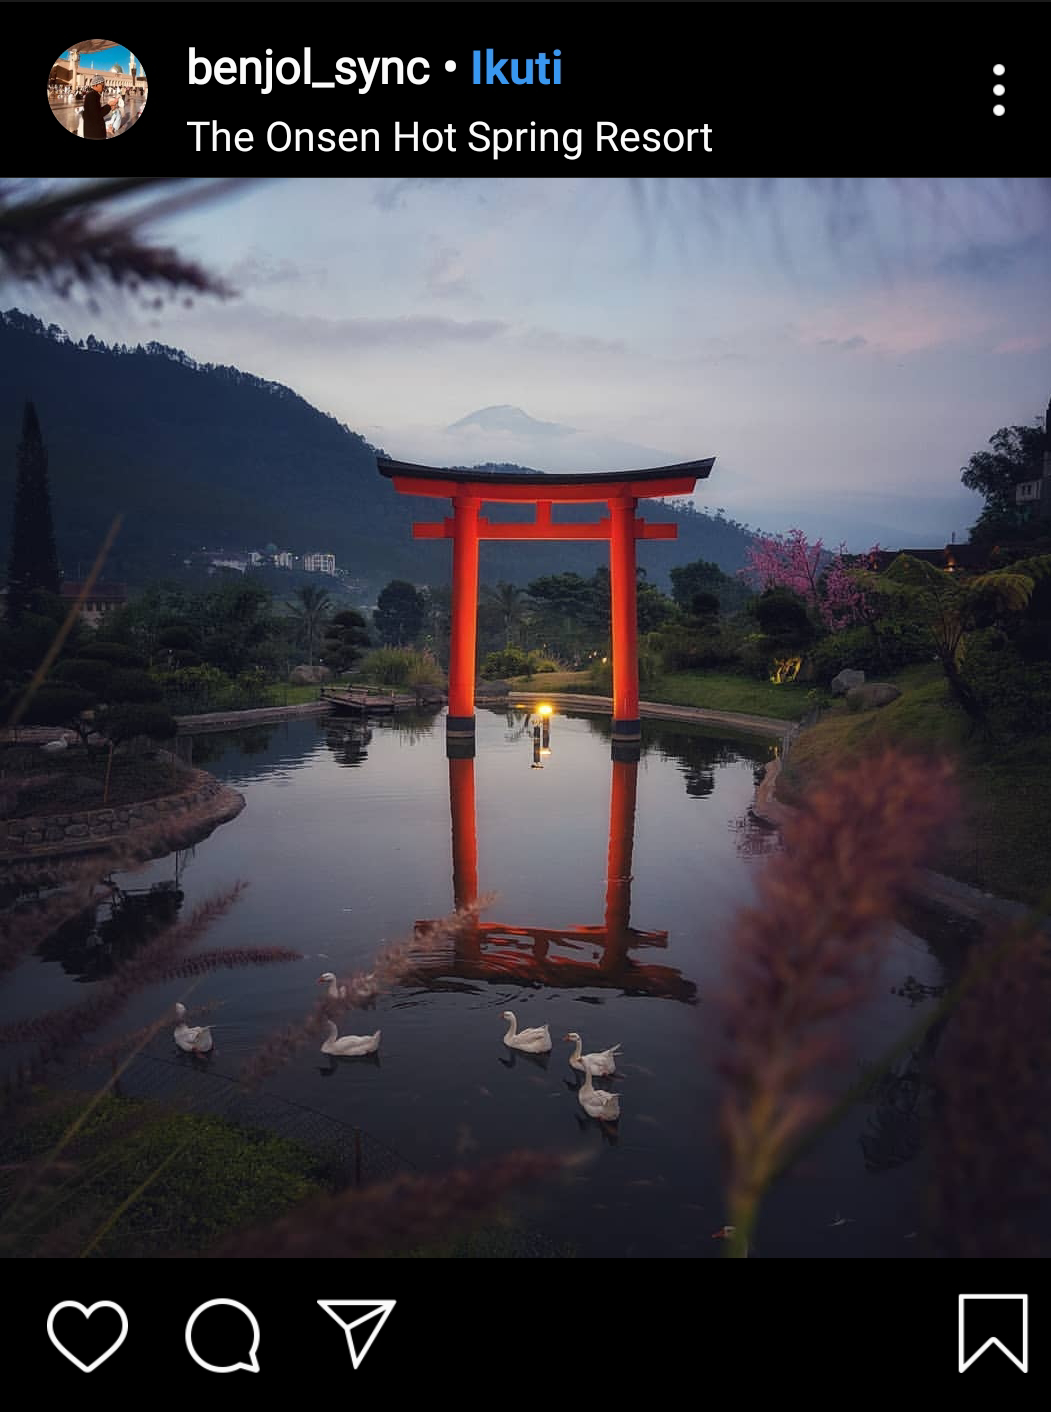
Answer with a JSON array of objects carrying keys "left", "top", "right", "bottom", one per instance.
[{"left": 740, "top": 530, "right": 880, "bottom": 631}]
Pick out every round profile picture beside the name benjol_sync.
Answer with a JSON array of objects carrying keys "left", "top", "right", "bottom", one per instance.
[{"left": 48, "top": 40, "right": 150, "bottom": 143}]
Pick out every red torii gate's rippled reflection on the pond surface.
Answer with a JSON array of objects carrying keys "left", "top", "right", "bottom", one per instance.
[{"left": 412, "top": 758, "right": 696, "bottom": 1003}]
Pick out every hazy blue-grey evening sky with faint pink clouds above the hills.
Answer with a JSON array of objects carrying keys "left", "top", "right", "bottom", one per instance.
[{"left": 14, "top": 175, "right": 1051, "bottom": 548}]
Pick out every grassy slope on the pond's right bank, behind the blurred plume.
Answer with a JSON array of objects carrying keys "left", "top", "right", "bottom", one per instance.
[{"left": 778, "top": 666, "right": 1051, "bottom": 902}]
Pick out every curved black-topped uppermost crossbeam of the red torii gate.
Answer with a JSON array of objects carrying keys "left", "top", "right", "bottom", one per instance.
[{"left": 376, "top": 456, "right": 715, "bottom": 504}]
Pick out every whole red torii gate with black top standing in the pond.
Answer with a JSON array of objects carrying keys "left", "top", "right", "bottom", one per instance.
[{"left": 376, "top": 456, "right": 715, "bottom": 755}]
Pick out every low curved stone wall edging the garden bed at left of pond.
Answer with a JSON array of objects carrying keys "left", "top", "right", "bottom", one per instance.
[{"left": 0, "top": 770, "right": 244, "bottom": 857}]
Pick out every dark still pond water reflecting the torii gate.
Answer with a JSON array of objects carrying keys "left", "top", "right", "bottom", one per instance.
[{"left": 0, "top": 709, "right": 945, "bottom": 1257}]
